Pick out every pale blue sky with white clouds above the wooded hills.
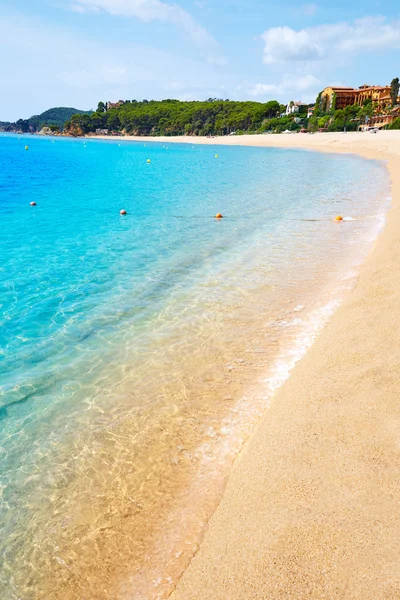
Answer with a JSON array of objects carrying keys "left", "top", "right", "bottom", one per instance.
[{"left": 0, "top": 0, "right": 400, "bottom": 121}]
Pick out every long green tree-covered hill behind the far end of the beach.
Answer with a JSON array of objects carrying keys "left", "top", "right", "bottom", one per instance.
[{"left": 65, "top": 99, "right": 285, "bottom": 135}]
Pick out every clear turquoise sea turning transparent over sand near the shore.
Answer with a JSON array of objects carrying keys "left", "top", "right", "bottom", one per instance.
[{"left": 0, "top": 134, "right": 390, "bottom": 600}]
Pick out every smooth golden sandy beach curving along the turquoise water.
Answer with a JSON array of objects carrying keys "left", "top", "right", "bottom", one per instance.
[{"left": 103, "top": 132, "right": 400, "bottom": 600}]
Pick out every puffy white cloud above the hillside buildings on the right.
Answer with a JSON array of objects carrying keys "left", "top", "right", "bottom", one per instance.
[{"left": 261, "top": 17, "right": 400, "bottom": 65}]
